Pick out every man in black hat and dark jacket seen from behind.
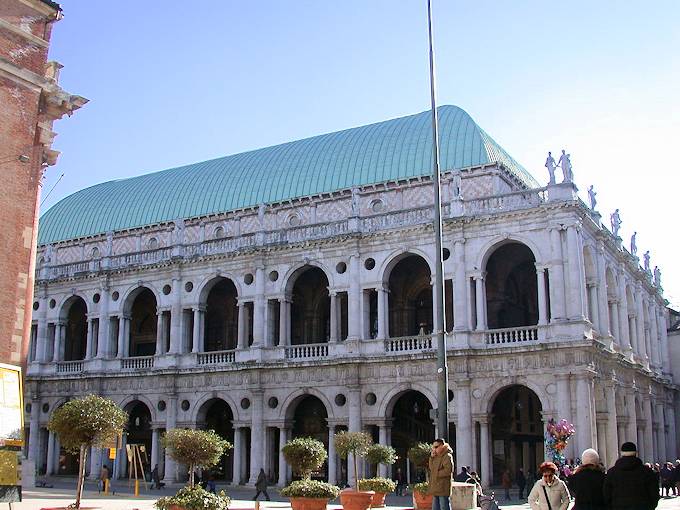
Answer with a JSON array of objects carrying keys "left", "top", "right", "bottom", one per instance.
[{"left": 603, "top": 442, "right": 659, "bottom": 510}]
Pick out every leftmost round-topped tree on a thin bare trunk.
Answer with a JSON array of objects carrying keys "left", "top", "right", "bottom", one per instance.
[{"left": 47, "top": 395, "right": 128, "bottom": 508}]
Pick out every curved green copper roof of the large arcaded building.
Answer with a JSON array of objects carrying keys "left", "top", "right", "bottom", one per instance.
[{"left": 38, "top": 106, "right": 538, "bottom": 245}]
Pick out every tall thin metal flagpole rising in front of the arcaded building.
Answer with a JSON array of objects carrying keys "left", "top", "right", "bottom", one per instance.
[{"left": 427, "top": 0, "right": 449, "bottom": 441}]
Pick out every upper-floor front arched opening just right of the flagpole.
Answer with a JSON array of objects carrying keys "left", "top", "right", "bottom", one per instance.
[{"left": 486, "top": 243, "right": 538, "bottom": 329}]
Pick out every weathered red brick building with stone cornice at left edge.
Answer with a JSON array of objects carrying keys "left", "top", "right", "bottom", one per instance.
[{"left": 0, "top": 0, "right": 87, "bottom": 364}]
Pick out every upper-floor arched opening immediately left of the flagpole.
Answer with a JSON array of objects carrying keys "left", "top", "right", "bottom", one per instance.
[{"left": 388, "top": 254, "right": 433, "bottom": 337}]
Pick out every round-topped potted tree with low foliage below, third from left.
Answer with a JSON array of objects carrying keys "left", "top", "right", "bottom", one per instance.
[{"left": 281, "top": 437, "right": 340, "bottom": 510}]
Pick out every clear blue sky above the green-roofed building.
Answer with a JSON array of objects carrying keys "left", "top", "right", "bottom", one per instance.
[{"left": 43, "top": 0, "right": 680, "bottom": 306}]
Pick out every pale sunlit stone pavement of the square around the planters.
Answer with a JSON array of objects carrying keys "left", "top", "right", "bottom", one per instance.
[{"left": 7, "top": 479, "right": 680, "bottom": 510}]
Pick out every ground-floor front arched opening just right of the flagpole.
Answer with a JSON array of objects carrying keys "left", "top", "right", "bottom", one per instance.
[{"left": 491, "top": 385, "right": 544, "bottom": 484}]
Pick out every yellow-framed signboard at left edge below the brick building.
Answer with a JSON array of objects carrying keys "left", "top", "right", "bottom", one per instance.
[{"left": 0, "top": 363, "right": 24, "bottom": 503}]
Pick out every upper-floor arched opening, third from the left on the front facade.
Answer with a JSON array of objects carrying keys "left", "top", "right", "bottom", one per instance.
[{"left": 205, "top": 278, "right": 238, "bottom": 351}]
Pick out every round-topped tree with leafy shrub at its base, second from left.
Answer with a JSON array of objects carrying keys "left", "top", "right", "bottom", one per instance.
[{"left": 155, "top": 429, "right": 232, "bottom": 510}]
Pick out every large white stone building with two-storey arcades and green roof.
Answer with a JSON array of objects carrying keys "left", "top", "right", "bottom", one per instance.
[{"left": 26, "top": 107, "right": 678, "bottom": 484}]
